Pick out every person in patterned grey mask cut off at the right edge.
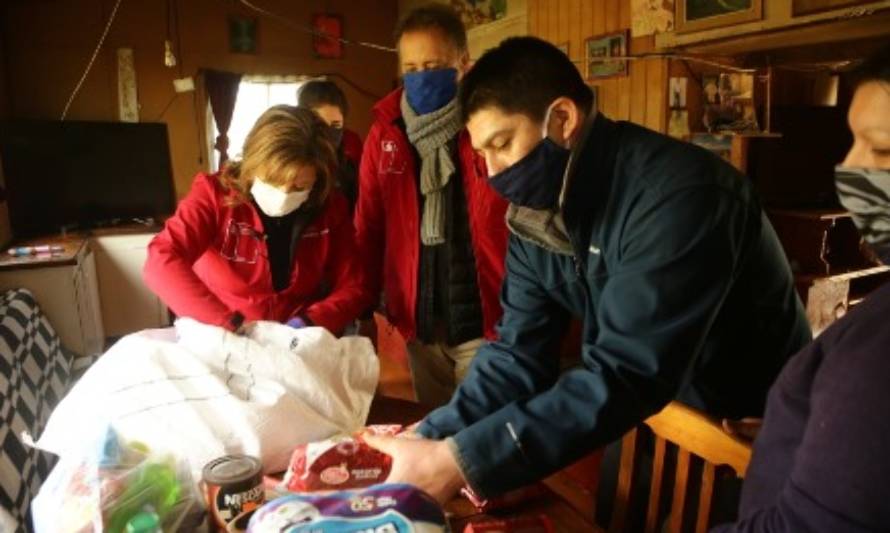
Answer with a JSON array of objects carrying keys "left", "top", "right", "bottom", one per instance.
[{"left": 716, "top": 40, "right": 890, "bottom": 533}]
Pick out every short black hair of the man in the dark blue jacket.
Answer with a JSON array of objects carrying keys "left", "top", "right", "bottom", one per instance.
[{"left": 458, "top": 37, "right": 593, "bottom": 122}]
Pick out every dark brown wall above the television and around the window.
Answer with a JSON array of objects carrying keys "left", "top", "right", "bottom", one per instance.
[{"left": 0, "top": 0, "right": 397, "bottom": 196}]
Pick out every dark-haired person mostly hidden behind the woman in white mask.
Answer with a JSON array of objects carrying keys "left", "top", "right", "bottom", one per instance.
[{"left": 297, "top": 80, "right": 362, "bottom": 212}]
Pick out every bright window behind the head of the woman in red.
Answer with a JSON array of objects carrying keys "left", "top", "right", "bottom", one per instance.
[{"left": 207, "top": 76, "right": 305, "bottom": 170}]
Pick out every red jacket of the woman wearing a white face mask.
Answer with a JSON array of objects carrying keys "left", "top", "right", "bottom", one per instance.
[{"left": 143, "top": 173, "right": 368, "bottom": 333}]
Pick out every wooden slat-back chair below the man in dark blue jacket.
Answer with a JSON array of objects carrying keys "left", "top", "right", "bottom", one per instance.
[{"left": 545, "top": 402, "right": 751, "bottom": 533}]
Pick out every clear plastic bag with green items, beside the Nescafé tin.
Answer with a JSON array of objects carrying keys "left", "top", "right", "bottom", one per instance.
[{"left": 32, "top": 429, "right": 204, "bottom": 533}]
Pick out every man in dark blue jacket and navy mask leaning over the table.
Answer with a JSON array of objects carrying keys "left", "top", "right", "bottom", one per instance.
[{"left": 364, "top": 37, "right": 810, "bottom": 501}]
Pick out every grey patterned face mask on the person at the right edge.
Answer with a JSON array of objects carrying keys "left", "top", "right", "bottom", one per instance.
[{"left": 834, "top": 166, "right": 890, "bottom": 265}]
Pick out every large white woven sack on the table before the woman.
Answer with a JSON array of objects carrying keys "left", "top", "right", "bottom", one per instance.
[{"left": 37, "top": 318, "right": 379, "bottom": 479}]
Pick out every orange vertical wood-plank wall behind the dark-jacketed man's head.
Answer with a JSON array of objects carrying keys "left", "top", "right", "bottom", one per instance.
[{"left": 528, "top": 0, "right": 668, "bottom": 132}]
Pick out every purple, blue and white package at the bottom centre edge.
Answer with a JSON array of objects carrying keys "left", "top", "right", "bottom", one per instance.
[{"left": 247, "top": 484, "right": 449, "bottom": 533}]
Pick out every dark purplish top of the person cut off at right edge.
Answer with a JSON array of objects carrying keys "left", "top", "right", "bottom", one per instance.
[{"left": 718, "top": 276, "right": 890, "bottom": 533}]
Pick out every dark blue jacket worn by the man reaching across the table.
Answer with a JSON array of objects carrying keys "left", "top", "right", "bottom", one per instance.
[{"left": 419, "top": 115, "right": 810, "bottom": 496}]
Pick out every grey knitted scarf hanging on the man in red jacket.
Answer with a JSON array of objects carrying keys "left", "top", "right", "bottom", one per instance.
[{"left": 401, "top": 93, "right": 463, "bottom": 246}]
